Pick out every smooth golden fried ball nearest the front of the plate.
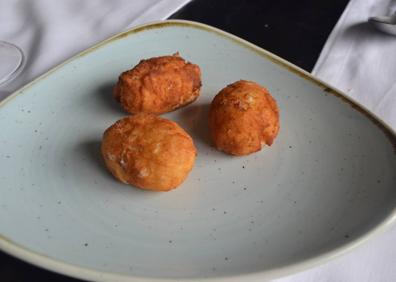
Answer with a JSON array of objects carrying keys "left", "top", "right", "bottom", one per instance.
[{"left": 101, "top": 113, "right": 197, "bottom": 191}]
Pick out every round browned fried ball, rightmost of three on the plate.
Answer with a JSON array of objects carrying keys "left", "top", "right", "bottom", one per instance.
[{"left": 209, "top": 80, "right": 279, "bottom": 156}]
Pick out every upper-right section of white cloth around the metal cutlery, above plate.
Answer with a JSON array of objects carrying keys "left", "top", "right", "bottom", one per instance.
[{"left": 313, "top": 0, "right": 396, "bottom": 130}]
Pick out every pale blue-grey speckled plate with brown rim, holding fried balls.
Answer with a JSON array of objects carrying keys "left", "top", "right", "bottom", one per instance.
[{"left": 0, "top": 21, "right": 396, "bottom": 281}]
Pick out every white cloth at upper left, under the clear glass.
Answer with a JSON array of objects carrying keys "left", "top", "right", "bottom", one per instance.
[{"left": 0, "top": 0, "right": 189, "bottom": 100}]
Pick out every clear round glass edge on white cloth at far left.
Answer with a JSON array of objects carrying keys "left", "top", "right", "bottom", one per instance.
[{"left": 0, "top": 40, "right": 25, "bottom": 85}]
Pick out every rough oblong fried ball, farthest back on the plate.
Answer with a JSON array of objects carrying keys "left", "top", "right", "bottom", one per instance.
[{"left": 113, "top": 53, "right": 201, "bottom": 114}]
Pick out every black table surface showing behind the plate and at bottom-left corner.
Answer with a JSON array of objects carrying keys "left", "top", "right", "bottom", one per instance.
[{"left": 0, "top": 0, "right": 348, "bottom": 282}]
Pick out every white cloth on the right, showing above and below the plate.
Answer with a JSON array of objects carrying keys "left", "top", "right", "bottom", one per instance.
[{"left": 276, "top": 0, "right": 396, "bottom": 282}]
